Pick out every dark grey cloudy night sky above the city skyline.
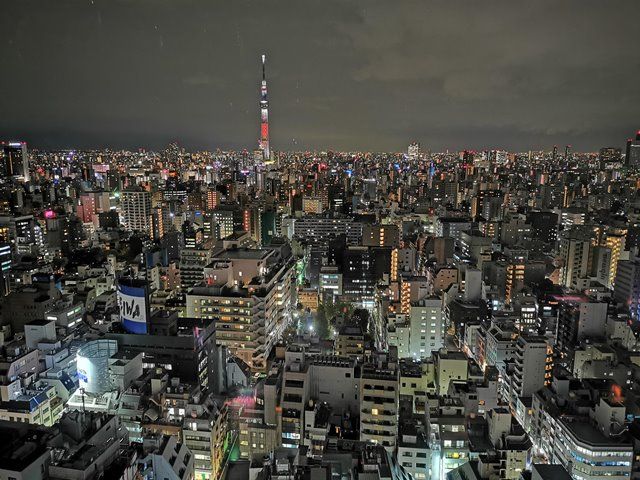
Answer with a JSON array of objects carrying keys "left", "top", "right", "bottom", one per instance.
[{"left": 0, "top": 0, "right": 640, "bottom": 151}]
